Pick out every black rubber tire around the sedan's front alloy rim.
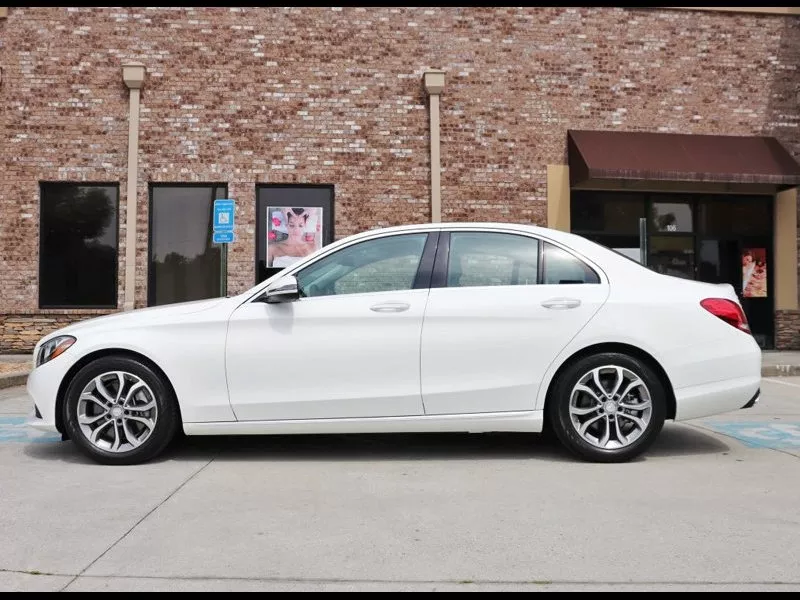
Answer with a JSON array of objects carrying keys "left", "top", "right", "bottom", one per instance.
[{"left": 63, "top": 356, "right": 180, "bottom": 465}]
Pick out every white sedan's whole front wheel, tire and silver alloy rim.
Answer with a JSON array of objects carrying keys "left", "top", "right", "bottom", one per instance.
[{"left": 64, "top": 356, "right": 179, "bottom": 465}]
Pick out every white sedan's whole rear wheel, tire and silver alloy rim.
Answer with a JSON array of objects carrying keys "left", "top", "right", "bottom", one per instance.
[{"left": 547, "top": 353, "right": 666, "bottom": 462}]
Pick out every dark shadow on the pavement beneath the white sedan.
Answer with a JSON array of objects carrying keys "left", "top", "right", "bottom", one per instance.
[{"left": 25, "top": 423, "right": 730, "bottom": 464}]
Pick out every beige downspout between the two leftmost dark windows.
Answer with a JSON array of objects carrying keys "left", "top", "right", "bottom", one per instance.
[{"left": 122, "top": 63, "right": 145, "bottom": 310}]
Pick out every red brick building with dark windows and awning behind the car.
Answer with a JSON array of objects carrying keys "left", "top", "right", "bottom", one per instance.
[{"left": 0, "top": 8, "right": 800, "bottom": 352}]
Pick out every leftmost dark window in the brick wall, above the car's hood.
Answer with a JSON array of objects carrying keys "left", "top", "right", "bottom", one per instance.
[{"left": 39, "top": 183, "right": 119, "bottom": 308}]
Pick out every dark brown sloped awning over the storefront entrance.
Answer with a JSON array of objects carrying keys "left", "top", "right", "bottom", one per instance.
[{"left": 567, "top": 131, "right": 800, "bottom": 187}]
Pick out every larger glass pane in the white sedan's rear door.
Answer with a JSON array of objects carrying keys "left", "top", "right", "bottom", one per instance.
[{"left": 447, "top": 232, "right": 539, "bottom": 287}]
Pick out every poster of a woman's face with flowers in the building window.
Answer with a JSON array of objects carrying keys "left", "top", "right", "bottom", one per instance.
[{"left": 267, "top": 206, "right": 322, "bottom": 269}]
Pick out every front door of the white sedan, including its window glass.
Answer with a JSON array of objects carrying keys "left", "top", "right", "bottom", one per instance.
[{"left": 226, "top": 232, "right": 438, "bottom": 421}]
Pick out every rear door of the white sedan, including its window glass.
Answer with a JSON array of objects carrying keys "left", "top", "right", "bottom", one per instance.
[{"left": 422, "top": 230, "right": 609, "bottom": 414}]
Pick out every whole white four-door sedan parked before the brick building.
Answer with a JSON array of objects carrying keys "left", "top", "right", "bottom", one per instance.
[{"left": 28, "top": 224, "right": 761, "bottom": 464}]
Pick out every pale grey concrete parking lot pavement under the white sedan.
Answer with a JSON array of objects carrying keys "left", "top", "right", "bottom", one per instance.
[{"left": 0, "top": 377, "right": 800, "bottom": 591}]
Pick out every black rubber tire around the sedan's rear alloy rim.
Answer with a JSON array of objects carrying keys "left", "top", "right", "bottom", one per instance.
[{"left": 547, "top": 352, "right": 667, "bottom": 463}]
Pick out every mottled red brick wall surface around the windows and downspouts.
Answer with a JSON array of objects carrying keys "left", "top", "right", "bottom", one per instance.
[{"left": 0, "top": 8, "right": 800, "bottom": 351}]
